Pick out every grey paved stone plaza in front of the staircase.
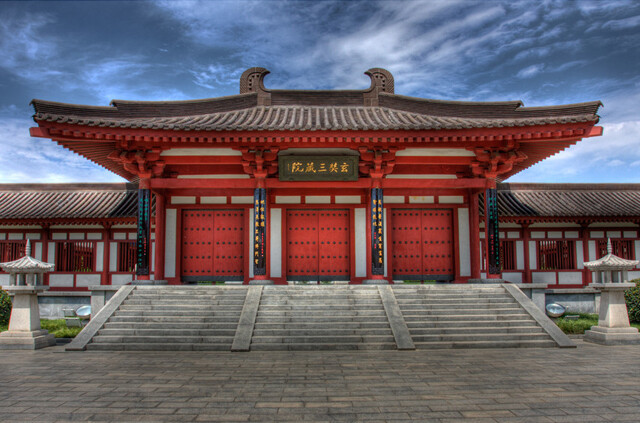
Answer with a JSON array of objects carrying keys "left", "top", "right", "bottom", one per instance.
[{"left": 0, "top": 341, "right": 640, "bottom": 422}]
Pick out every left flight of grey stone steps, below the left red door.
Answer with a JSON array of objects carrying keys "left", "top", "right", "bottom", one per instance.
[{"left": 87, "top": 286, "right": 247, "bottom": 351}]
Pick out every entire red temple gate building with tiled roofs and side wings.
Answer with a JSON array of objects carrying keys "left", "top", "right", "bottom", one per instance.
[{"left": 0, "top": 68, "right": 640, "bottom": 290}]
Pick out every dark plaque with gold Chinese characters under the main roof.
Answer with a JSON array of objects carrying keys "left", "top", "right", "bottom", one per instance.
[{"left": 278, "top": 156, "right": 358, "bottom": 181}]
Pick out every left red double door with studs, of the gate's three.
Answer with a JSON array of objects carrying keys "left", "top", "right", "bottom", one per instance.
[{"left": 181, "top": 210, "right": 244, "bottom": 282}]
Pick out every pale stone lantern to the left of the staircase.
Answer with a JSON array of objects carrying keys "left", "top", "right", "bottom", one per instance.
[{"left": 0, "top": 240, "right": 56, "bottom": 350}]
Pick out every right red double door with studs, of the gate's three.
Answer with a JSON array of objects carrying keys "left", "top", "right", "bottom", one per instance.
[{"left": 390, "top": 209, "right": 455, "bottom": 281}]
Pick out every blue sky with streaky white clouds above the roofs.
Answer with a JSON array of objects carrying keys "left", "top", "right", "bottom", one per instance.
[{"left": 0, "top": 0, "right": 640, "bottom": 183}]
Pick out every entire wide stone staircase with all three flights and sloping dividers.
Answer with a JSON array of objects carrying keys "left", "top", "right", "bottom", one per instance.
[{"left": 72, "top": 284, "right": 575, "bottom": 351}]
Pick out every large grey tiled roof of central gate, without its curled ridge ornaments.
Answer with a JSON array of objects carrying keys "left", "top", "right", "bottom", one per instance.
[{"left": 32, "top": 90, "right": 601, "bottom": 131}]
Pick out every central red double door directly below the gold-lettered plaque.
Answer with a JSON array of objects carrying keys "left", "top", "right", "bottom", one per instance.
[{"left": 286, "top": 209, "right": 350, "bottom": 281}]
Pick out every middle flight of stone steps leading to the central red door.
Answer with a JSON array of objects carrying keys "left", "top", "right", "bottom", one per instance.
[{"left": 251, "top": 285, "right": 396, "bottom": 351}]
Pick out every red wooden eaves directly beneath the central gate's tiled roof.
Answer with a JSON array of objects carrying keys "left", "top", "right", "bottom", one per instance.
[{"left": 31, "top": 122, "right": 602, "bottom": 181}]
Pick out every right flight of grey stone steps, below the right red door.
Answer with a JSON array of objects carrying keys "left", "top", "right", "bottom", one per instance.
[{"left": 394, "top": 285, "right": 556, "bottom": 349}]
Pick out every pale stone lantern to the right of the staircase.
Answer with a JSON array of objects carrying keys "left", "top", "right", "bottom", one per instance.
[{"left": 584, "top": 240, "right": 640, "bottom": 345}]
